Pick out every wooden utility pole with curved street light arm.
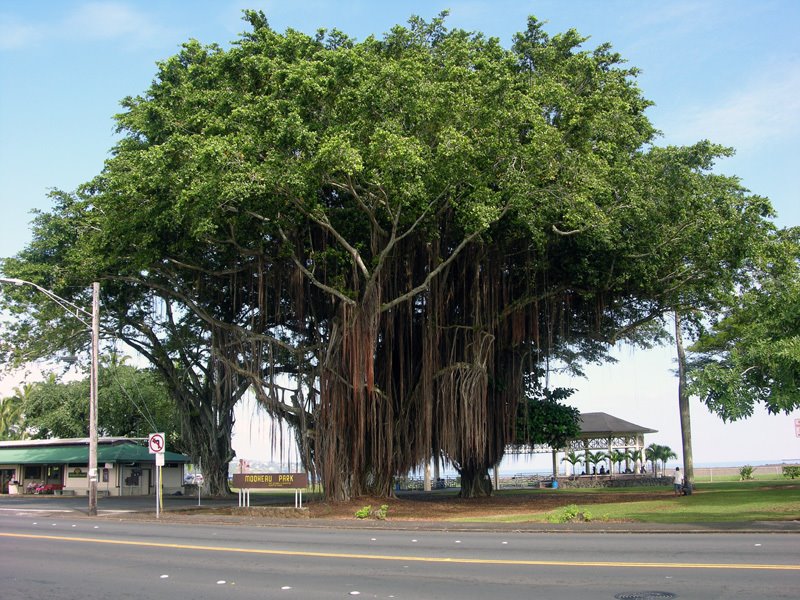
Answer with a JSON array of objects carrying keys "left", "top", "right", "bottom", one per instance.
[{"left": 0, "top": 277, "right": 100, "bottom": 517}]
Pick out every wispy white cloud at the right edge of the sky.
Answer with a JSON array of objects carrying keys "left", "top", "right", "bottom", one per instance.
[{"left": 659, "top": 63, "right": 800, "bottom": 151}]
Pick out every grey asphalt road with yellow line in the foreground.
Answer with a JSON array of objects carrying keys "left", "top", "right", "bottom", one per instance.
[{"left": 0, "top": 504, "right": 800, "bottom": 600}]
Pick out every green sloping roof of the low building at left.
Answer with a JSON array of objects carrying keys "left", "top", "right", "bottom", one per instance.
[{"left": 0, "top": 444, "right": 192, "bottom": 465}]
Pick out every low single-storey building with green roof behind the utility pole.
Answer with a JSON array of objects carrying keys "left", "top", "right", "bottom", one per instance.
[{"left": 0, "top": 438, "right": 191, "bottom": 496}]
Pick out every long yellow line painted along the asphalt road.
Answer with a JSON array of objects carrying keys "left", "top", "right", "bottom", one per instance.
[{"left": 0, "top": 533, "right": 800, "bottom": 571}]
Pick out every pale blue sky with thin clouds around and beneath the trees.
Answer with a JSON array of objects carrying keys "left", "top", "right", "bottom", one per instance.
[{"left": 0, "top": 0, "right": 800, "bottom": 470}]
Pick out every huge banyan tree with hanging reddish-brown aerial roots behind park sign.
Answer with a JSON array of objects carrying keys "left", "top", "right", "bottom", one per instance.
[{"left": 1, "top": 12, "right": 776, "bottom": 499}]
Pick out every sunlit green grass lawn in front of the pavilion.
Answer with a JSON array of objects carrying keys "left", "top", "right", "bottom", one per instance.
[{"left": 458, "top": 479, "right": 800, "bottom": 523}]
